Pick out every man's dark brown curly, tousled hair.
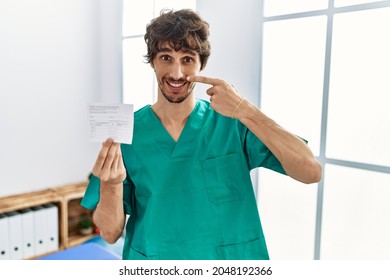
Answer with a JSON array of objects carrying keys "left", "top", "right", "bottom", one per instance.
[{"left": 144, "top": 9, "right": 211, "bottom": 69}]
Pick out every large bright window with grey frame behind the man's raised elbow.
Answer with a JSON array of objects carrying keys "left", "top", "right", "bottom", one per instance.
[{"left": 259, "top": 0, "right": 390, "bottom": 259}]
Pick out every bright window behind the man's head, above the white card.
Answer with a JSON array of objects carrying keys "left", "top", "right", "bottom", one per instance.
[{"left": 122, "top": 0, "right": 196, "bottom": 110}]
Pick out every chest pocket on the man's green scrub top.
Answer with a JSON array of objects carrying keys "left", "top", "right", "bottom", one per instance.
[{"left": 202, "top": 153, "right": 245, "bottom": 205}]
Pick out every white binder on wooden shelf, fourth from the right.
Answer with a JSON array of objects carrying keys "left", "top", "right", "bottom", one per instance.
[{"left": 6, "top": 211, "right": 23, "bottom": 260}]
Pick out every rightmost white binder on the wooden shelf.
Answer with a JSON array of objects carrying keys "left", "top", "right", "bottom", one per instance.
[{"left": 44, "top": 203, "right": 59, "bottom": 252}]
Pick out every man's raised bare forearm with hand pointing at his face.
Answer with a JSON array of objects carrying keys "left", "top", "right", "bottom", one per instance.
[{"left": 235, "top": 101, "right": 322, "bottom": 183}]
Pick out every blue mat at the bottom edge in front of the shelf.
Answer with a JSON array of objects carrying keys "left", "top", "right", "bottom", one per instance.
[{"left": 38, "top": 242, "right": 121, "bottom": 260}]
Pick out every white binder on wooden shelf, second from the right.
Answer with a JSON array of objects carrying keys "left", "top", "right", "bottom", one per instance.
[{"left": 32, "top": 206, "right": 47, "bottom": 256}]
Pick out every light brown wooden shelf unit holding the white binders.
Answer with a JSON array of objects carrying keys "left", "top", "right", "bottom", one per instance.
[{"left": 0, "top": 182, "right": 95, "bottom": 257}]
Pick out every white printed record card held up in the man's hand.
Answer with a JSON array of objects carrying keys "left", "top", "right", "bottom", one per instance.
[{"left": 88, "top": 103, "right": 134, "bottom": 144}]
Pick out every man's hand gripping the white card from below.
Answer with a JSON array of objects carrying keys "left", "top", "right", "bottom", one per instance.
[{"left": 92, "top": 138, "right": 126, "bottom": 185}]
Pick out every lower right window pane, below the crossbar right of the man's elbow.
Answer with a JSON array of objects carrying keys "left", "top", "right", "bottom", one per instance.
[{"left": 321, "top": 165, "right": 390, "bottom": 260}]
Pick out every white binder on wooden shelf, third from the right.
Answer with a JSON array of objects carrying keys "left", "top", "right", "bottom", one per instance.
[{"left": 19, "top": 208, "right": 35, "bottom": 259}]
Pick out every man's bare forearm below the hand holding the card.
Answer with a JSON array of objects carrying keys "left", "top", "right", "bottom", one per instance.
[{"left": 93, "top": 182, "right": 125, "bottom": 244}]
